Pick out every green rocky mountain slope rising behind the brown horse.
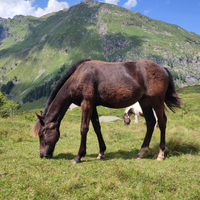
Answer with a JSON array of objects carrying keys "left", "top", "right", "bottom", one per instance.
[{"left": 0, "top": 0, "right": 200, "bottom": 109}]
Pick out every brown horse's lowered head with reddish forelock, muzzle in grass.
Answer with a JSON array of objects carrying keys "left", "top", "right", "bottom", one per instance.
[{"left": 33, "top": 114, "right": 60, "bottom": 158}]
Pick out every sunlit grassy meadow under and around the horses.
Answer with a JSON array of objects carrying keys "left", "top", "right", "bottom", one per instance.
[{"left": 0, "top": 93, "right": 200, "bottom": 200}]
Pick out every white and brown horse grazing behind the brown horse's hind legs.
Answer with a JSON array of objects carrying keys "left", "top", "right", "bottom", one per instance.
[{"left": 123, "top": 101, "right": 158, "bottom": 127}]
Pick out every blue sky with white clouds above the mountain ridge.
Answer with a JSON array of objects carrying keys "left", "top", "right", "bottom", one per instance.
[{"left": 0, "top": 0, "right": 200, "bottom": 35}]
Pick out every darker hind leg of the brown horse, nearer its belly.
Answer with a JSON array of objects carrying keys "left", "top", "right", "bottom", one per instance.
[{"left": 137, "top": 104, "right": 156, "bottom": 159}]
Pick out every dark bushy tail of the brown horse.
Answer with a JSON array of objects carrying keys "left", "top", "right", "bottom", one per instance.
[{"left": 165, "top": 68, "right": 181, "bottom": 112}]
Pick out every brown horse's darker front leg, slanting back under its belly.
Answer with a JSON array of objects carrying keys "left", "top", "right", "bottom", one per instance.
[{"left": 91, "top": 107, "right": 106, "bottom": 159}]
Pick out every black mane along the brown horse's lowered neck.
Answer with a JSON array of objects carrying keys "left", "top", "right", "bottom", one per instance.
[{"left": 43, "top": 59, "right": 90, "bottom": 115}]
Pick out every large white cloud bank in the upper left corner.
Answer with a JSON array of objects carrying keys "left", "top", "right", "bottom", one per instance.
[{"left": 0, "top": 0, "right": 69, "bottom": 18}]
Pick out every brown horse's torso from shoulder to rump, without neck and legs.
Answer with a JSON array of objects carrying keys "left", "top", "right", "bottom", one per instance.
[{"left": 68, "top": 60, "right": 167, "bottom": 108}]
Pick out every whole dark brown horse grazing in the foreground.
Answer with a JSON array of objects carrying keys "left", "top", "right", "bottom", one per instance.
[{"left": 34, "top": 59, "right": 181, "bottom": 163}]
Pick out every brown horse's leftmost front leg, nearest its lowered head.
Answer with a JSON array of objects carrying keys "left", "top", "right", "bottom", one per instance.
[{"left": 72, "top": 100, "right": 93, "bottom": 164}]
